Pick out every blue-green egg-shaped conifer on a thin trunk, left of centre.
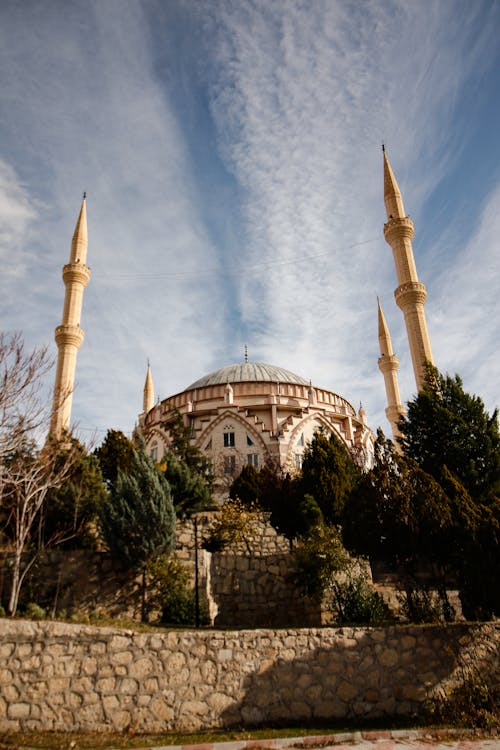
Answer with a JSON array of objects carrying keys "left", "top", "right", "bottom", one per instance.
[{"left": 99, "top": 448, "right": 175, "bottom": 620}]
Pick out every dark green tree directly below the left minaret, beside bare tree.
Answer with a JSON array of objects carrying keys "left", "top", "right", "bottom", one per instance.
[{"left": 40, "top": 438, "right": 107, "bottom": 549}]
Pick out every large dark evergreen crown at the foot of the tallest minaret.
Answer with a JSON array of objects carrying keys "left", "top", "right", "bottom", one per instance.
[{"left": 399, "top": 364, "right": 500, "bottom": 502}]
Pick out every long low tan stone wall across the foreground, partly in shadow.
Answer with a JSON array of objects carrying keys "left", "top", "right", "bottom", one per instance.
[{"left": 0, "top": 619, "right": 500, "bottom": 732}]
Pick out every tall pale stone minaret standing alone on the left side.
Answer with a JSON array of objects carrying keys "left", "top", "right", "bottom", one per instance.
[{"left": 50, "top": 193, "right": 90, "bottom": 439}]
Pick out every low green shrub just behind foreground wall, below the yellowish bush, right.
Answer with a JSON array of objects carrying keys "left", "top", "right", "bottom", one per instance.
[{"left": 331, "top": 574, "right": 391, "bottom": 626}]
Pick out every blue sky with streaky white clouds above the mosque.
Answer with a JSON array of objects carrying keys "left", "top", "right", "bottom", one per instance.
[{"left": 0, "top": 0, "right": 500, "bottom": 441}]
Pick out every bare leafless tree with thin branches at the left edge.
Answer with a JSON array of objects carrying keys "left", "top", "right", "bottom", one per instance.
[{"left": 0, "top": 333, "right": 74, "bottom": 615}]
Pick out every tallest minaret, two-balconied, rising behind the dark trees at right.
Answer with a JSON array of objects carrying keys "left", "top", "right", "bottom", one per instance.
[{"left": 382, "top": 146, "right": 434, "bottom": 391}]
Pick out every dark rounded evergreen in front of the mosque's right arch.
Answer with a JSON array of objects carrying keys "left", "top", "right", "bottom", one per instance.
[{"left": 299, "top": 431, "right": 360, "bottom": 524}]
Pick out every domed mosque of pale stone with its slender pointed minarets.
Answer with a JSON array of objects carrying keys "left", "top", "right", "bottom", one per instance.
[{"left": 51, "top": 149, "right": 433, "bottom": 496}]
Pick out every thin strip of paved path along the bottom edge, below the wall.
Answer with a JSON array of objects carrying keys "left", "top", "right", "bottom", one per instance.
[{"left": 149, "top": 729, "right": 500, "bottom": 750}]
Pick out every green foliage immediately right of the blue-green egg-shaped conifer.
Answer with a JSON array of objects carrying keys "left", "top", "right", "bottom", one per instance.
[{"left": 159, "top": 452, "right": 211, "bottom": 517}]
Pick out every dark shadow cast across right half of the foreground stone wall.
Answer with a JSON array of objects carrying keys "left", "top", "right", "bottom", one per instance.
[{"left": 221, "top": 625, "right": 500, "bottom": 727}]
